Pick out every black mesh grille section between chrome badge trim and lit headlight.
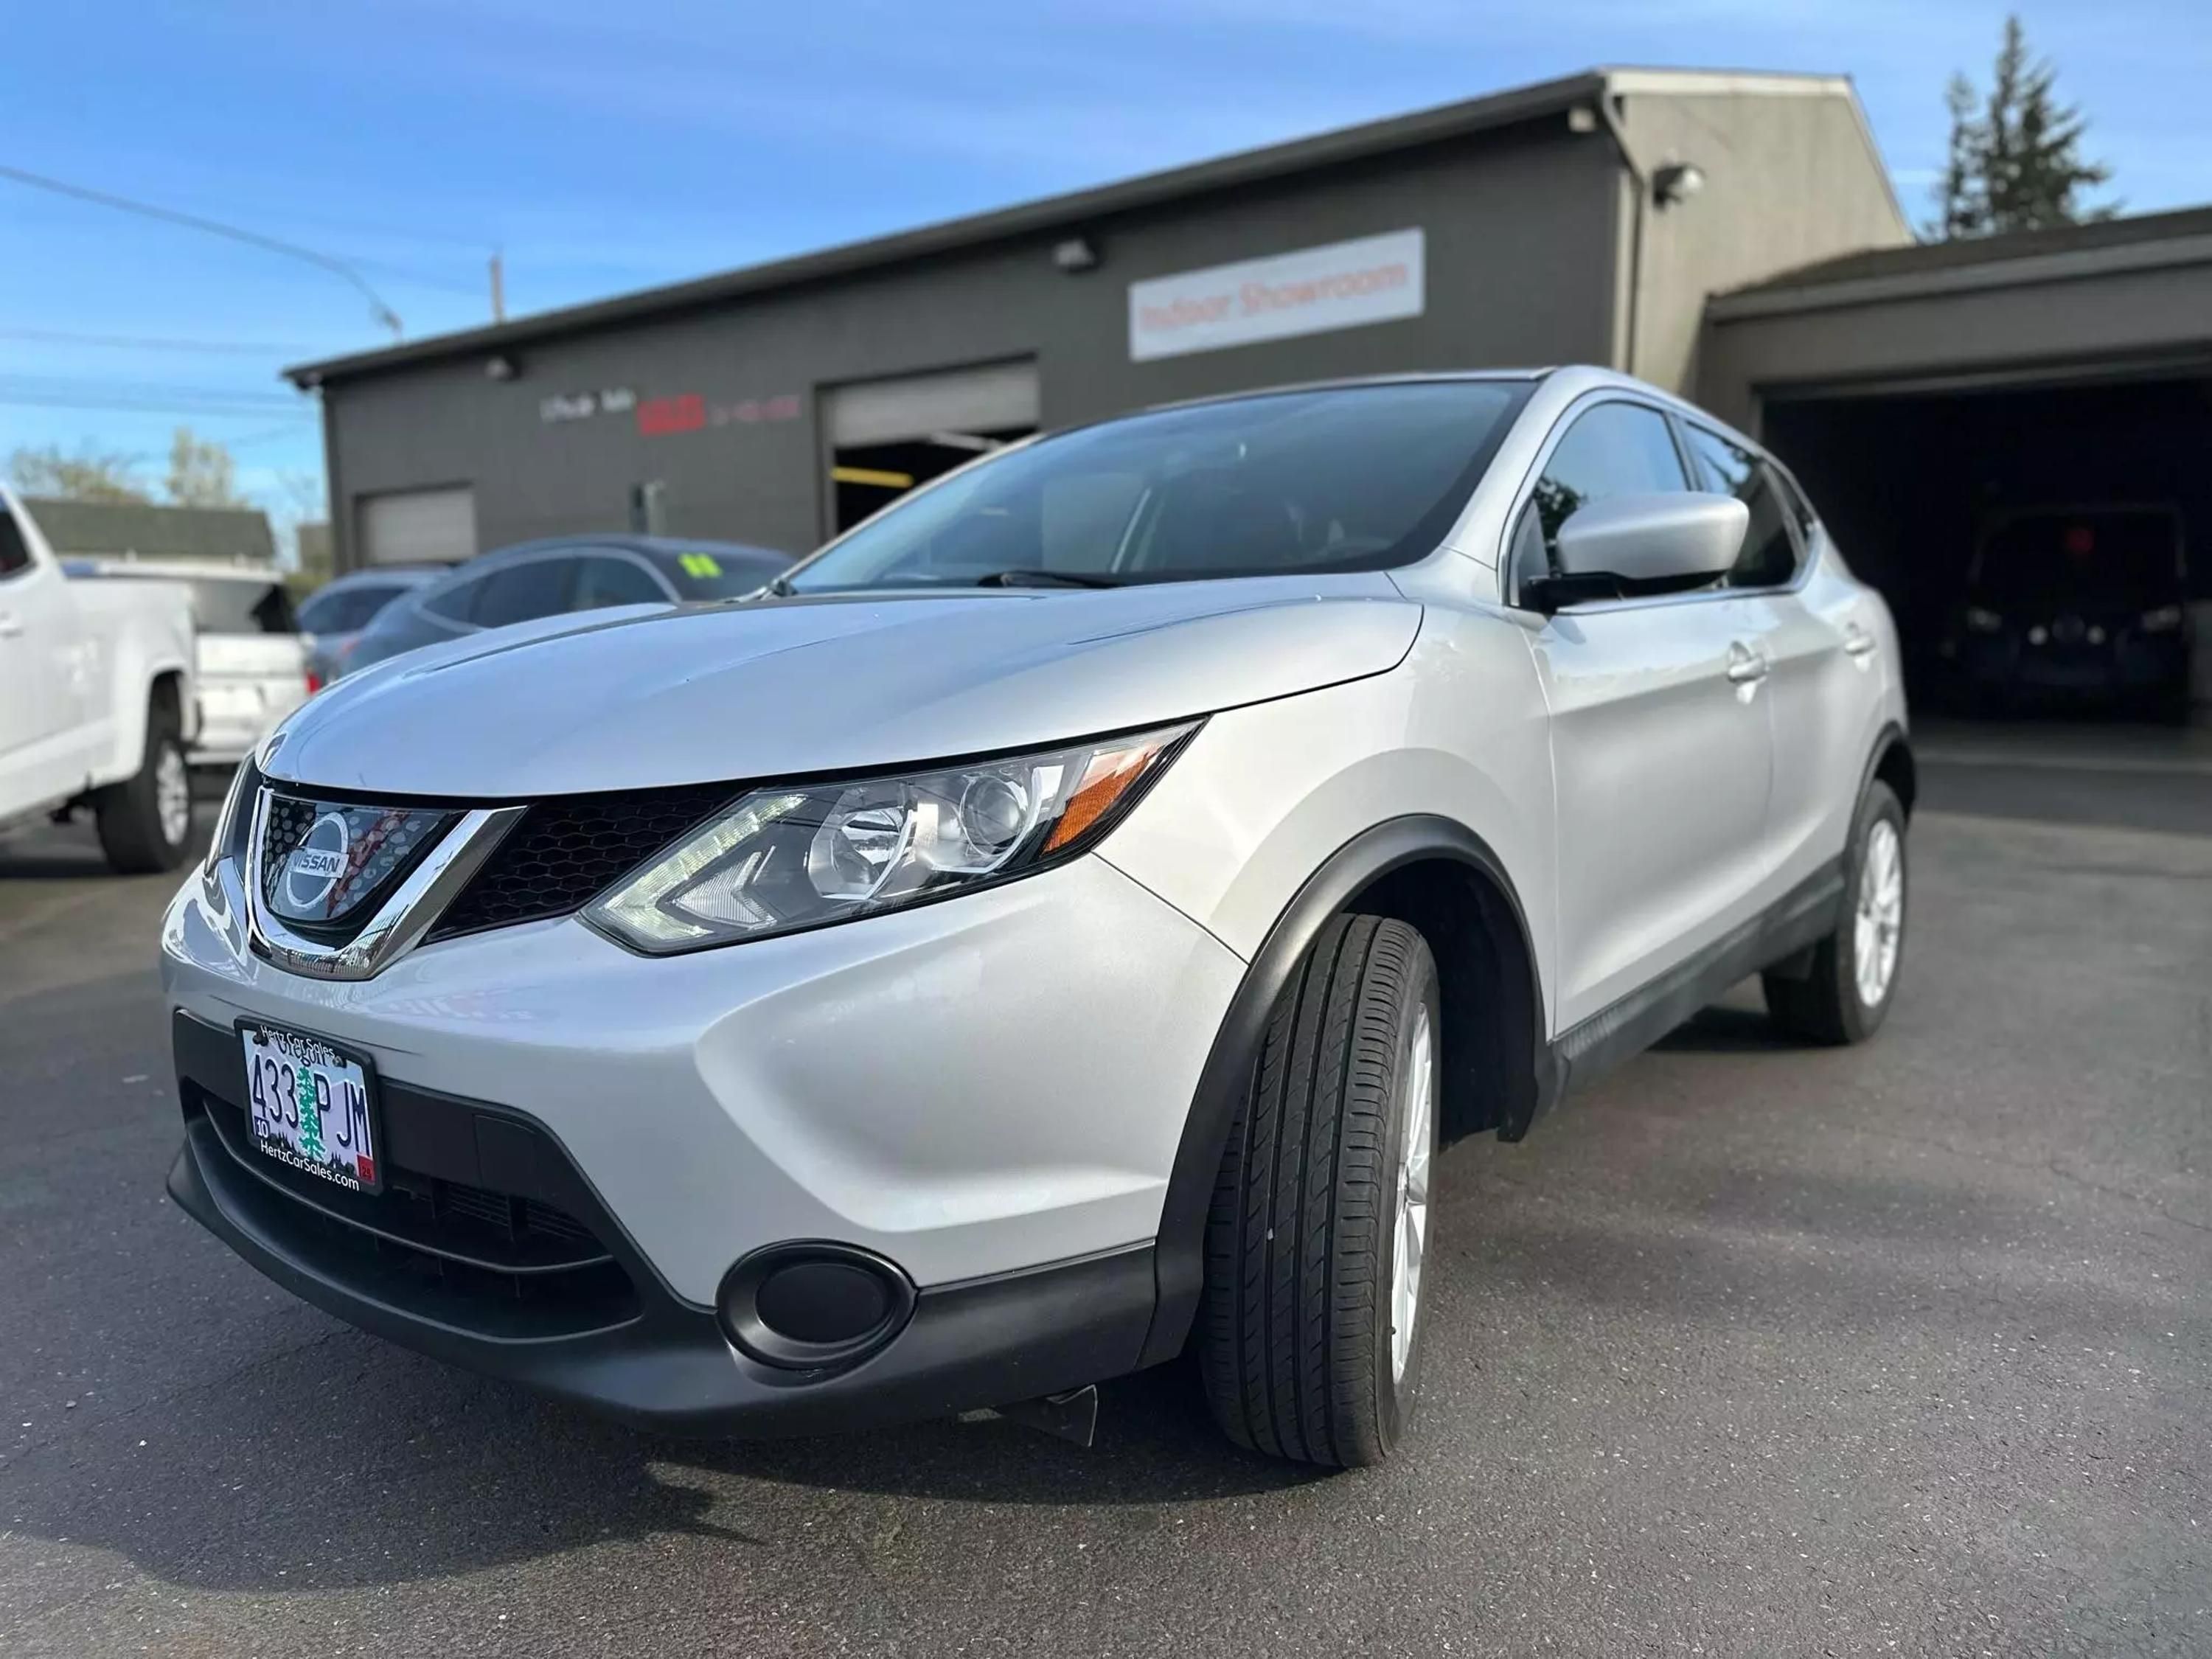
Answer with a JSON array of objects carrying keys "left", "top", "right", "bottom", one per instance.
[{"left": 429, "top": 783, "right": 737, "bottom": 940}]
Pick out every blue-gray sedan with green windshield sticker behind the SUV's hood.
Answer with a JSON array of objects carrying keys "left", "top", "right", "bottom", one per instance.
[{"left": 345, "top": 535, "right": 792, "bottom": 672}]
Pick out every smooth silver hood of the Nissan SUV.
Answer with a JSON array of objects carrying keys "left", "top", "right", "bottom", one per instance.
[{"left": 261, "top": 573, "right": 1420, "bottom": 801}]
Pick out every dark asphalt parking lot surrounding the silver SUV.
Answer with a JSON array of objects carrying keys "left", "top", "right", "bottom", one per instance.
[{"left": 0, "top": 732, "right": 2212, "bottom": 1657}]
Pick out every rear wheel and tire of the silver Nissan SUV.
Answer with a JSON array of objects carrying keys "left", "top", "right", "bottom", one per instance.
[{"left": 1761, "top": 779, "right": 1911, "bottom": 1044}]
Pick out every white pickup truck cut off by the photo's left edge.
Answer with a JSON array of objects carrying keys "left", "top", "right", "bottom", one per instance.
[{"left": 0, "top": 484, "right": 199, "bottom": 874}]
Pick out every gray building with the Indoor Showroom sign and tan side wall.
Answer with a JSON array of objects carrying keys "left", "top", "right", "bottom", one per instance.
[{"left": 290, "top": 71, "right": 1911, "bottom": 568}]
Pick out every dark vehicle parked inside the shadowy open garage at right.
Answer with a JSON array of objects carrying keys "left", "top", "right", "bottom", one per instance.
[{"left": 1947, "top": 504, "right": 2190, "bottom": 719}]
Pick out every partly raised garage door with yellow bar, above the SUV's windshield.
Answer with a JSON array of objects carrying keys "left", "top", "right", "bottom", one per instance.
[{"left": 823, "top": 361, "right": 1037, "bottom": 531}]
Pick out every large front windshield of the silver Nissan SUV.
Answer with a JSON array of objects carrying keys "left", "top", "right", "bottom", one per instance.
[{"left": 787, "top": 380, "right": 1531, "bottom": 593}]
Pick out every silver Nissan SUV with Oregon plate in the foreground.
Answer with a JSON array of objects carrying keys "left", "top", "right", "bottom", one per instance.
[{"left": 161, "top": 369, "right": 1913, "bottom": 1464}]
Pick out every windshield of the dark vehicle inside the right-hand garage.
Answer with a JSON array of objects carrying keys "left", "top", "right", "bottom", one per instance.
[{"left": 1973, "top": 509, "right": 2181, "bottom": 611}]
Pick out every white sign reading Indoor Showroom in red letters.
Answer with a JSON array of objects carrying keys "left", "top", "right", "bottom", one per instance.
[{"left": 1128, "top": 226, "right": 1427, "bottom": 363}]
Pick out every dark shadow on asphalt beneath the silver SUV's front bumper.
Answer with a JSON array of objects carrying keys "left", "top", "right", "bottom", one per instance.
[{"left": 0, "top": 1303, "right": 1323, "bottom": 1593}]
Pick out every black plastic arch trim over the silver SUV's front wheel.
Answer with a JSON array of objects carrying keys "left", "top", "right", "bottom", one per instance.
[{"left": 1141, "top": 814, "right": 1557, "bottom": 1365}]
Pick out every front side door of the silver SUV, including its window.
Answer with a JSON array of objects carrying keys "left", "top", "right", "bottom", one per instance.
[{"left": 1513, "top": 394, "right": 1774, "bottom": 1031}]
